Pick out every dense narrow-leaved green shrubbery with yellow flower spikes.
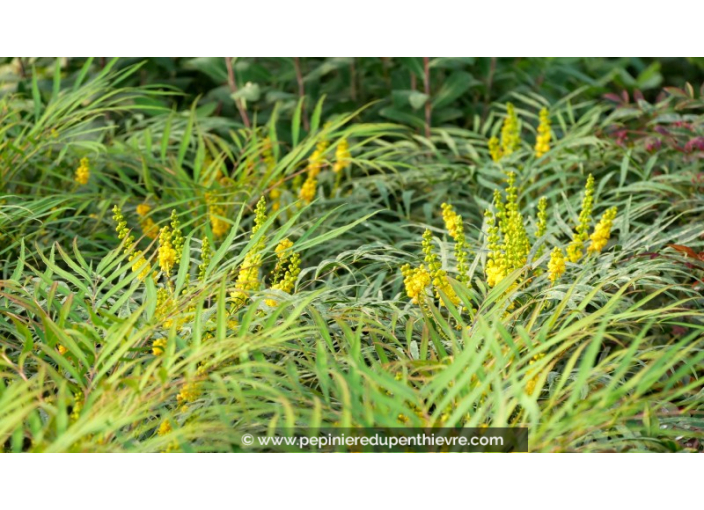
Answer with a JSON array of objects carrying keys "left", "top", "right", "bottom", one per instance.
[{"left": 0, "top": 59, "right": 704, "bottom": 451}]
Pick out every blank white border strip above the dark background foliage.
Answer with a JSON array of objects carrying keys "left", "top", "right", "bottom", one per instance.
[{"left": 0, "top": 0, "right": 704, "bottom": 56}]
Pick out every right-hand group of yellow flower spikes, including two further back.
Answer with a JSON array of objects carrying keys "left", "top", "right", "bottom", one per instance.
[{"left": 401, "top": 103, "right": 617, "bottom": 316}]
